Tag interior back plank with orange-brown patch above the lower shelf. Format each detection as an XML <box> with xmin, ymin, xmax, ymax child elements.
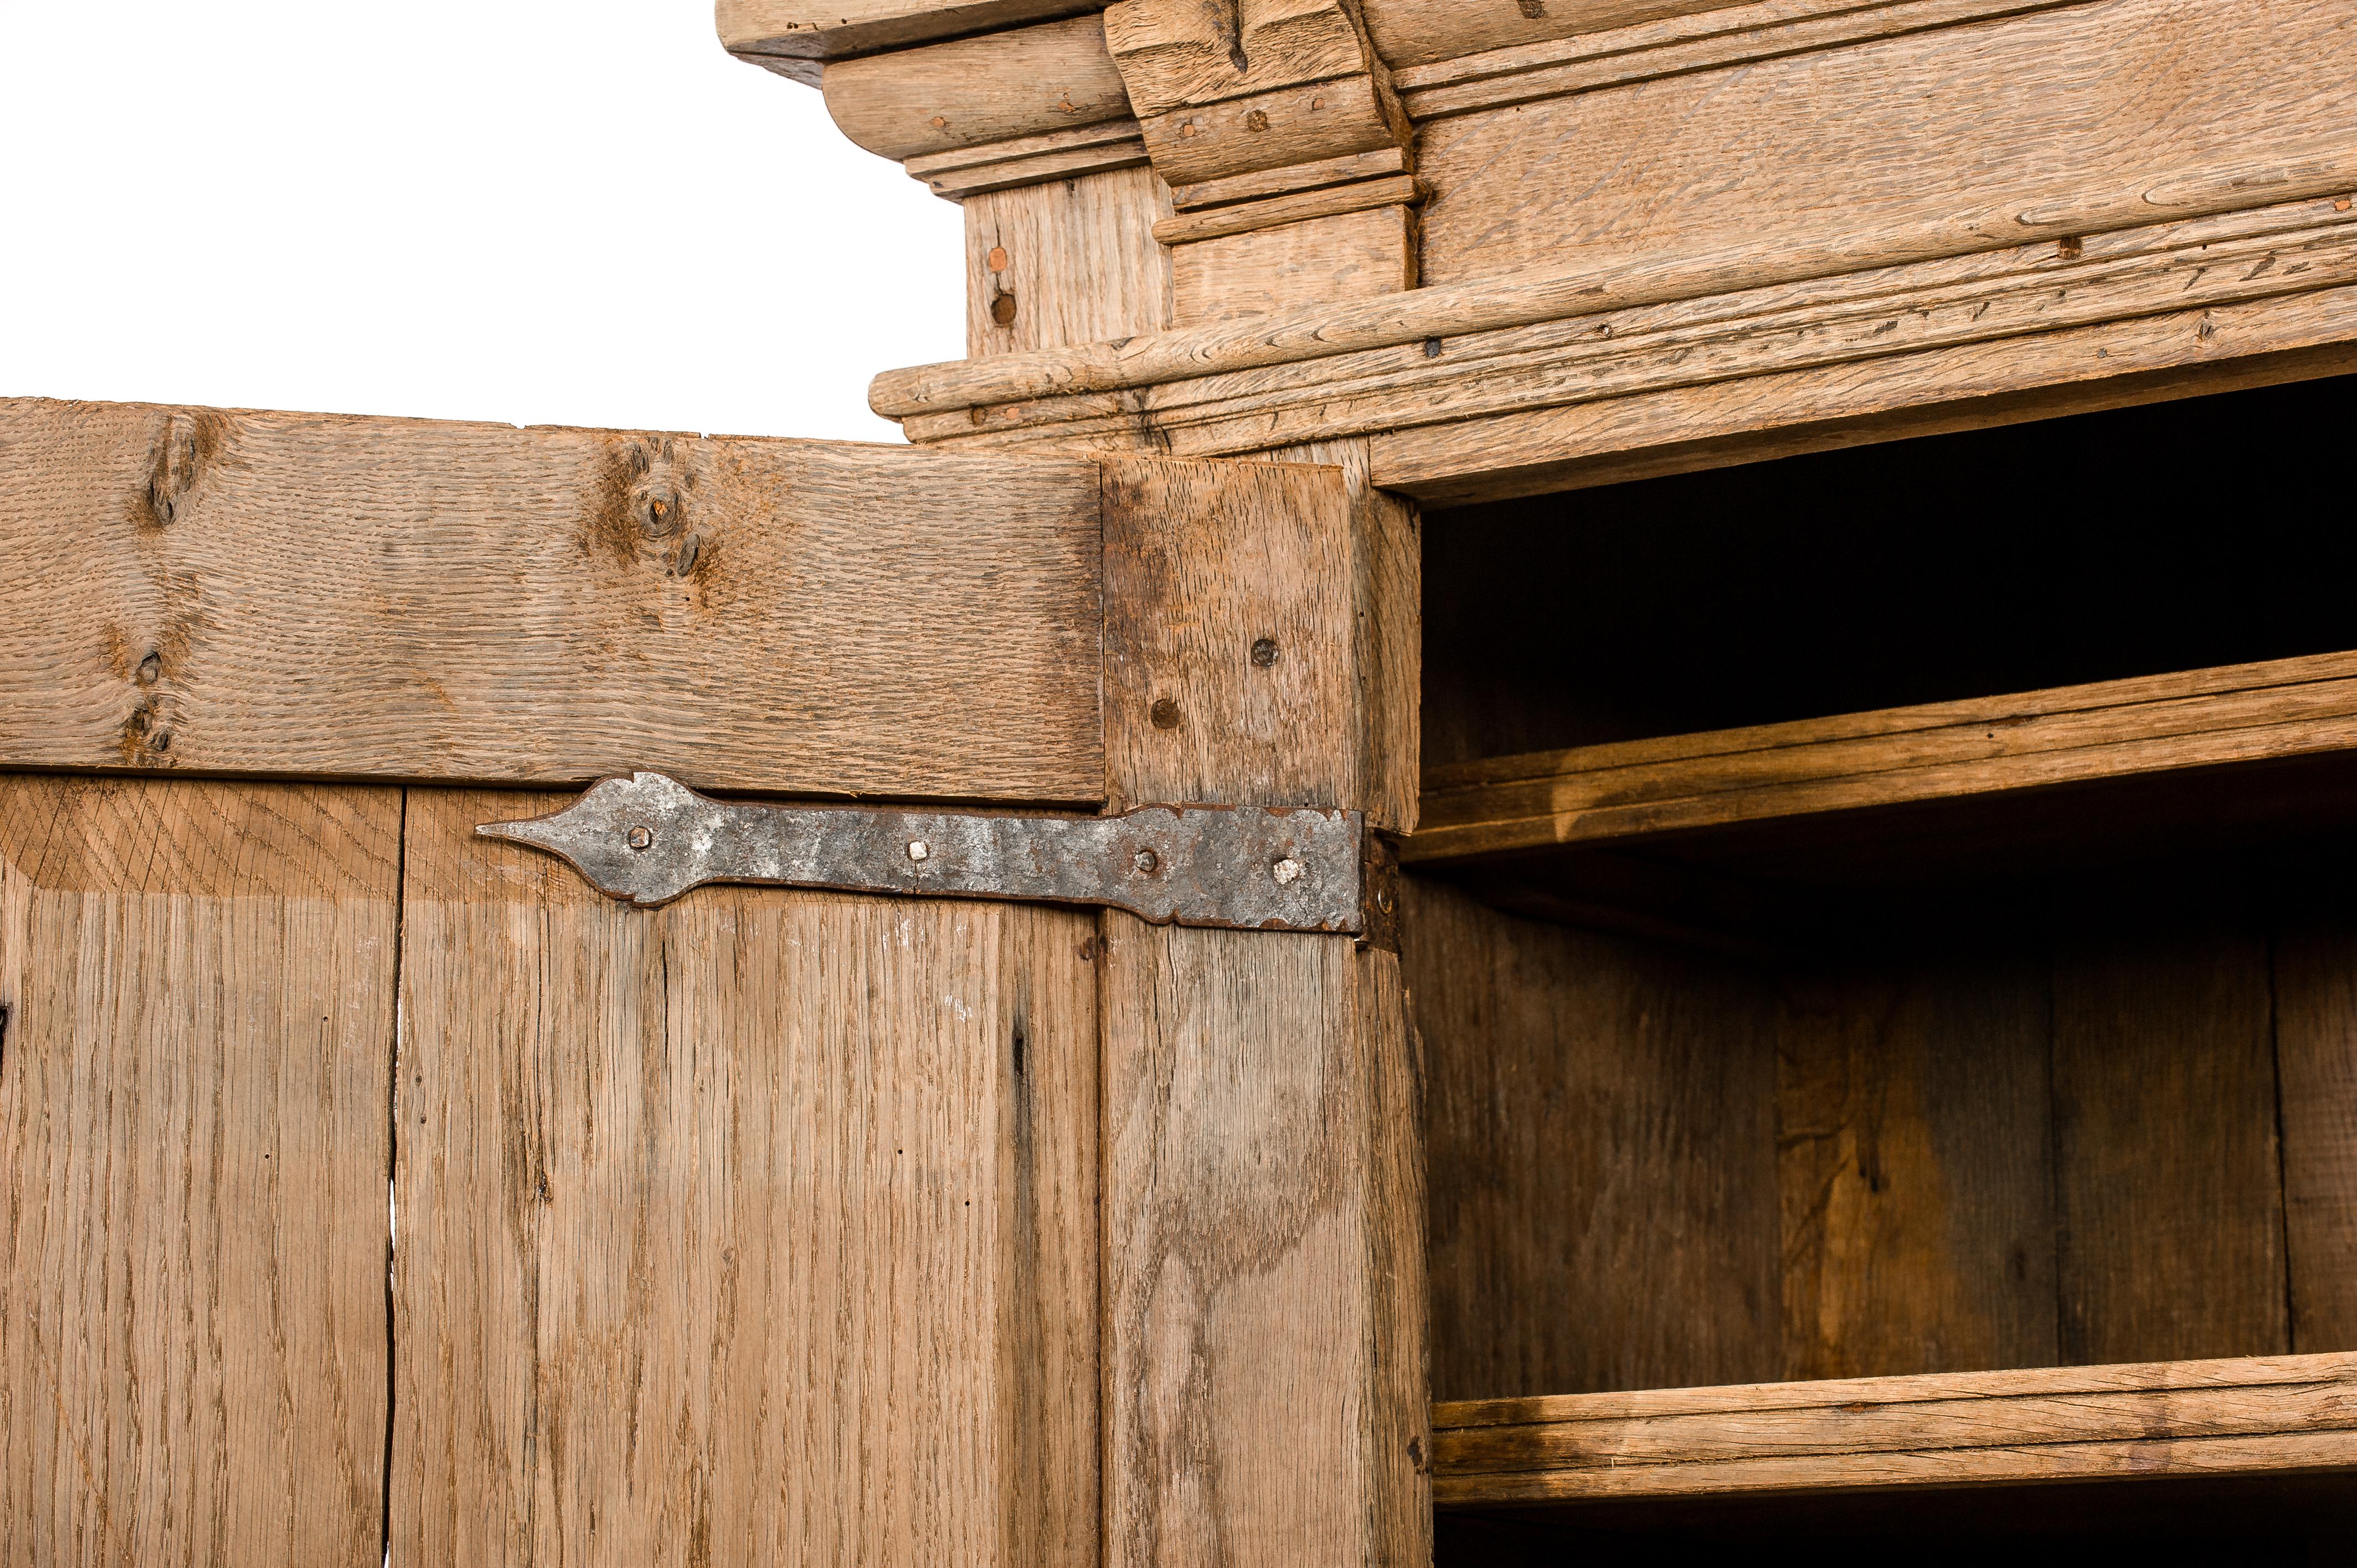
<box><xmin>1777</xmin><ymin>955</ymin><xmax>2057</xmax><ymax>1379</ymax></box>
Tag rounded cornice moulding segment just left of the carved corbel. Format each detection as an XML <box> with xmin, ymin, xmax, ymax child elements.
<box><xmin>825</xmin><ymin>17</ymin><xmax>1129</xmax><ymax>161</ymax></box>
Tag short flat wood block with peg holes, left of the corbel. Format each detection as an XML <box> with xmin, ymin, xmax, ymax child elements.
<box><xmin>966</xmin><ymin>167</ymin><xmax>1171</xmax><ymax>358</ymax></box>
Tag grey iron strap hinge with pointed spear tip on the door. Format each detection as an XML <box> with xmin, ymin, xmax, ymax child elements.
<box><xmin>476</xmin><ymin>773</ymin><xmax>1398</xmax><ymax>948</ymax></box>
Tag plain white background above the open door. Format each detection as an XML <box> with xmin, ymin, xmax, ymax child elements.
<box><xmin>0</xmin><ymin>0</ymin><xmax>964</xmax><ymax>441</ymax></box>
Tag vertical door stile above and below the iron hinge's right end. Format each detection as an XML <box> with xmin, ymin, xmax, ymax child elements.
<box><xmin>1098</xmin><ymin>450</ymin><xmax>1430</xmax><ymax>1568</ymax></box>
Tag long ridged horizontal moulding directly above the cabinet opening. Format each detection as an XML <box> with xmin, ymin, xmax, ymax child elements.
<box><xmin>869</xmin><ymin>194</ymin><xmax>2357</xmax><ymax>471</ymax></box>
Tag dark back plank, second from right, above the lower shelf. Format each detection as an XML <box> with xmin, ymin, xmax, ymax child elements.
<box><xmin>2053</xmin><ymin>910</ymin><xmax>2291</xmax><ymax>1365</ymax></box>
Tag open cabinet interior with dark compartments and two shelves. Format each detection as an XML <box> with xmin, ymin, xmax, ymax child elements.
<box><xmin>1405</xmin><ymin>380</ymin><xmax>2357</xmax><ymax>1561</ymax></box>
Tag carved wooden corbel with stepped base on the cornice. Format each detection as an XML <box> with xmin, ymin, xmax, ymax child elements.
<box><xmin>1105</xmin><ymin>0</ymin><xmax>1421</xmax><ymax>326</ymax></box>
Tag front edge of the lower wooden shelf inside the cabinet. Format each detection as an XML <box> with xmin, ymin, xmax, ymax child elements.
<box><xmin>1433</xmin><ymin>1353</ymin><xmax>2357</xmax><ymax>1509</ymax></box>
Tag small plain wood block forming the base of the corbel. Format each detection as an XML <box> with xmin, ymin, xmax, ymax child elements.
<box><xmin>1171</xmin><ymin>205</ymin><xmax>1417</xmax><ymax>326</ymax></box>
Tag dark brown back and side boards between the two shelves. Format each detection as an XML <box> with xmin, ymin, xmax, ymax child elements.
<box><xmin>1405</xmin><ymin>868</ymin><xmax>2357</xmax><ymax>1398</ymax></box>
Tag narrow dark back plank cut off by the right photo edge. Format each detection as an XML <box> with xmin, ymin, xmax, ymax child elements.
<box><xmin>2274</xmin><ymin>917</ymin><xmax>2357</xmax><ymax>1351</ymax></box>
